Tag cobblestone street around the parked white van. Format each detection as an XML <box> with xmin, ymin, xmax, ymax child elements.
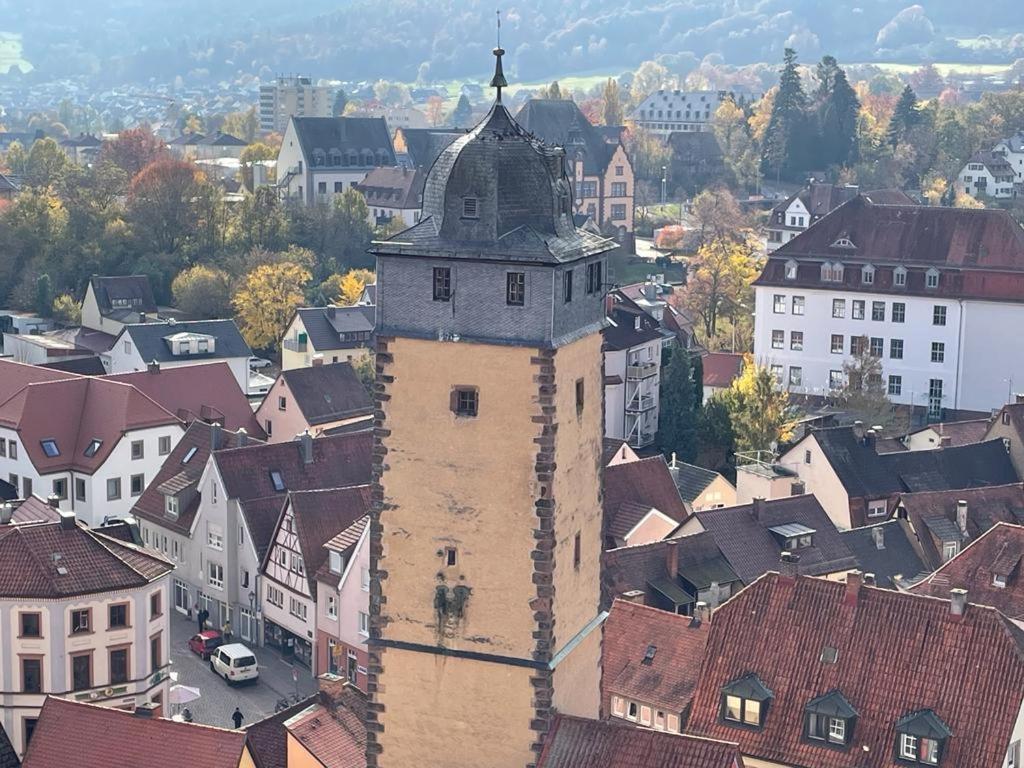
<box><xmin>169</xmin><ymin>612</ymin><xmax>316</xmax><ymax>728</ymax></box>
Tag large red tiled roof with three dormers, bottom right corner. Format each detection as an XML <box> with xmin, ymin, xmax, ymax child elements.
<box><xmin>688</xmin><ymin>573</ymin><xmax>1024</xmax><ymax>768</ymax></box>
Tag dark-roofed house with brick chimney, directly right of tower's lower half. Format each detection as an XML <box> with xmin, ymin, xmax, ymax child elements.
<box><xmin>601</xmin><ymin>532</ymin><xmax>743</xmax><ymax>615</ymax></box>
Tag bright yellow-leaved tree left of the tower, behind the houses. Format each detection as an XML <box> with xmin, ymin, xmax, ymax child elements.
<box><xmin>231</xmin><ymin>261</ymin><xmax>312</xmax><ymax>349</ymax></box>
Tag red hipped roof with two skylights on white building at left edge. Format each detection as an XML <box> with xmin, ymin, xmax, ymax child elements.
<box><xmin>0</xmin><ymin>374</ymin><xmax>180</xmax><ymax>474</ymax></box>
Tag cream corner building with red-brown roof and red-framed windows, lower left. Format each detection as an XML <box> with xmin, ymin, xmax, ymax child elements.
<box><xmin>0</xmin><ymin>512</ymin><xmax>174</xmax><ymax>766</ymax></box>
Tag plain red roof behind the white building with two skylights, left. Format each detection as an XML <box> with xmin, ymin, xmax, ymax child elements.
<box><xmin>103</xmin><ymin>360</ymin><xmax>264</xmax><ymax>438</ymax></box>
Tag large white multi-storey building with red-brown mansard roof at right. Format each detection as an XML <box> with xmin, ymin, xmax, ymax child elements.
<box><xmin>754</xmin><ymin>197</ymin><xmax>1024</xmax><ymax>419</ymax></box>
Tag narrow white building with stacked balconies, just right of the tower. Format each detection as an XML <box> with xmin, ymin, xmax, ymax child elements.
<box><xmin>601</xmin><ymin>293</ymin><xmax>665</xmax><ymax>447</ymax></box>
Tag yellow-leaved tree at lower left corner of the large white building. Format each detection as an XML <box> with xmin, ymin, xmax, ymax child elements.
<box><xmin>718</xmin><ymin>354</ymin><xmax>797</xmax><ymax>452</ymax></box>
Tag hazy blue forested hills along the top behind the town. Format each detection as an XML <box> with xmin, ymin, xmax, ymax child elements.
<box><xmin>0</xmin><ymin>0</ymin><xmax>1024</xmax><ymax>84</ymax></box>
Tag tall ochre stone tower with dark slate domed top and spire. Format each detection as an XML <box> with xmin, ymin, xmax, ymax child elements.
<box><xmin>368</xmin><ymin>48</ymin><xmax>614</xmax><ymax>768</ymax></box>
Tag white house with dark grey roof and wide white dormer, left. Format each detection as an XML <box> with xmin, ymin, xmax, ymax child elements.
<box><xmin>100</xmin><ymin>319</ymin><xmax>252</xmax><ymax>393</ymax></box>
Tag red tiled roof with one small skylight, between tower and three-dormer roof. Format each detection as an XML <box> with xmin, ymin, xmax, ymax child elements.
<box><xmin>601</xmin><ymin>600</ymin><xmax>708</xmax><ymax>714</ymax></box>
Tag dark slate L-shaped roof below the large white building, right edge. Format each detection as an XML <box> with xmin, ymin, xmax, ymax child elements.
<box><xmin>812</xmin><ymin>427</ymin><xmax>1019</xmax><ymax>498</ymax></box>
